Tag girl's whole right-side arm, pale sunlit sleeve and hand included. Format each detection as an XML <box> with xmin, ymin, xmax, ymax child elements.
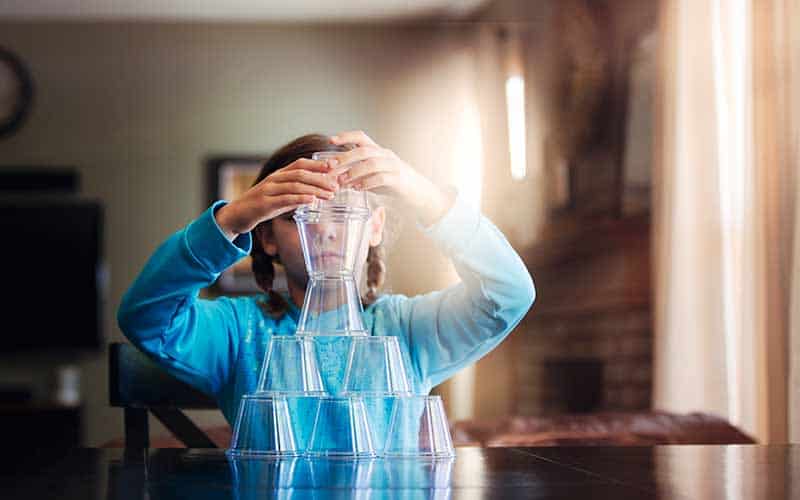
<box><xmin>331</xmin><ymin>131</ymin><xmax>535</xmax><ymax>388</ymax></box>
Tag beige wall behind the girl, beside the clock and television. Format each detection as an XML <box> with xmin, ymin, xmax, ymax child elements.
<box><xmin>0</xmin><ymin>23</ymin><xmax>512</xmax><ymax>445</ymax></box>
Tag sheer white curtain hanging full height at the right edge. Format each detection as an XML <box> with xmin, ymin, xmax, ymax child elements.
<box><xmin>654</xmin><ymin>0</ymin><xmax>798</xmax><ymax>442</ymax></box>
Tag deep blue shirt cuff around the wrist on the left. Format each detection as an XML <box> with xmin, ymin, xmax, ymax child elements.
<box><xmin>186</xmin><ymin>200</ymin><xmax>253</xmax><ymax>274</ymax></box>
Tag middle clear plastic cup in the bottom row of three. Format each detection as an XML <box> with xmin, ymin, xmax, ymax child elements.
<box><xmin>307</xmin><ymin>397</ymin><xmax>375</xmax><ymax>458</ymax></box>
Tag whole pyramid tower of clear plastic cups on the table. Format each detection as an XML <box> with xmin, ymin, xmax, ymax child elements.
<box><xmin>228</xmin><ymin>153</ymin><xmax>454</xmax><ymax>458</ymax></box>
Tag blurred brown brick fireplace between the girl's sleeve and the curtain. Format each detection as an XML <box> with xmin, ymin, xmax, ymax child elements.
<box><xmin>512</xmin><ymin>215</ymin><xmax>653</xmax><ymax>415</ymax></box>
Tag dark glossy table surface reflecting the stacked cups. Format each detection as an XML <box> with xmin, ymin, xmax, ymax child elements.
<box><xmin>0</xmin><ymin>445</ymin><xmax>800</xmax><ymax>500</ymax></box>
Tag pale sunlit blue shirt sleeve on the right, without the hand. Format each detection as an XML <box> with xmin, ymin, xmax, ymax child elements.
<box><xmin>395</xmin><ymin>191</ymin><xmax>535</xmax><ymax>389</ymax></box>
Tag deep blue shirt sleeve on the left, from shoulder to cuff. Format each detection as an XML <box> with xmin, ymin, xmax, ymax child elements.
<box><xmin>117</xmin><ymin>201</ymin><xmax>252</xmax><ymax>395</ymax></box>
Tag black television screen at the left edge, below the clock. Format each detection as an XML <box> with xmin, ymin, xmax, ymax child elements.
<box><xmin>0</xmin><ymin>196</ymin><xmax>103</xmax><ymax>352</ymax></box>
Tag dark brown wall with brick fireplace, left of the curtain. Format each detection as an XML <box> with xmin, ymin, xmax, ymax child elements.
<box><xmin>477</xmin><ymin>0</ymin><xmax>655</xmax><ymax>417</ymax></box>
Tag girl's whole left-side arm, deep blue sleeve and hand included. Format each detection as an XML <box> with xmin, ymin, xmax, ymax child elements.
<box><xmin>117</xmin><ymin>158</ymin><xmax>338</xmax><ymax>394</ymax></box>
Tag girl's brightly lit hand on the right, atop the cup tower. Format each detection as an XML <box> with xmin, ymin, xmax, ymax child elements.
<box><xmin>331</xmin><ymin>131</ymin><xmax>453</xmax><ymax>225</ymax></box>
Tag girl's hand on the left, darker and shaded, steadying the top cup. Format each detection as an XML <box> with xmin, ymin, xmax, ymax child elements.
<box><xmin>214</xmin><ymin>158</ymin><xmax>339</xmax><ymax>240</ymax></box>
